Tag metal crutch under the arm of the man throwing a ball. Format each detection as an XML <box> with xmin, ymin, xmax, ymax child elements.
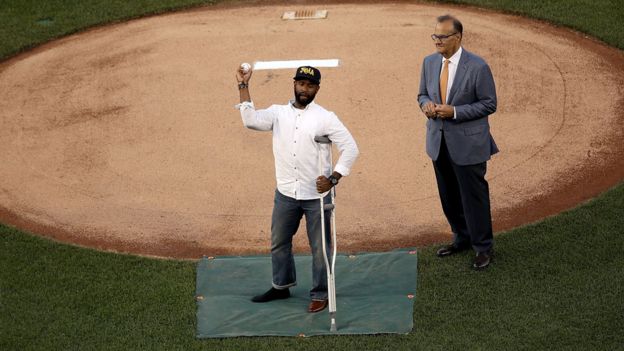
<box><xmin>314</xmin><ymin>136</ymin><xmax>338</xmax><ymax>332</ymax></box>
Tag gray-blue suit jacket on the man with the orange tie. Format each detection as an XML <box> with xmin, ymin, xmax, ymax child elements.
<box><xmin>418</xmin><ymin>49</ymin><xmax>498</xmax><ymax>166</ymax></box>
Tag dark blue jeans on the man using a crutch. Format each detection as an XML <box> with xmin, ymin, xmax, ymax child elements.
<box><xmin>271</xmin><ymin>190</ymin><xmax>331</xmax><ymax>300</ymax></box>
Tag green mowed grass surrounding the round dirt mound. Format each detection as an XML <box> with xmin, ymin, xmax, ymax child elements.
<box><xmin>0</xmin><ymin>0</ymin><xmax>624</xmax><ymax>350</ymax></box>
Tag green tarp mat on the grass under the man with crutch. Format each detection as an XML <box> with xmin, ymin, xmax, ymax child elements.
<box><xmin>196</xmin><ymin>250</ymin><xmax>417</xmax><ymax>338</ymax></box>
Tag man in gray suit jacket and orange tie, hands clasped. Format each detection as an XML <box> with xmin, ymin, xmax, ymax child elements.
<box><xmin>418</xmin><ymin>15</ymin><xmax>498</xmax><ymax>269</ymax></box>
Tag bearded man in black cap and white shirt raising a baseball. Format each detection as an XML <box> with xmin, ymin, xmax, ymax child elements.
<box><xmin>236</xmin><ymin>66</ymin><xmax>359</xmax><ymax>312</ymax></box>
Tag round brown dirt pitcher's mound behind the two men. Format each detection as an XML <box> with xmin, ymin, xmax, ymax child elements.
<box><xmin>0</xmin><ymin>3</ymin><xmax>624</xmax><ymax>258</ymax></box>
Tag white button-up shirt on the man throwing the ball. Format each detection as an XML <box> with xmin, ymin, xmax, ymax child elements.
<box><xmin>236</xmin><ymin>101</ymin><xmax>359</xmax><ymax>200</ymax></box>
